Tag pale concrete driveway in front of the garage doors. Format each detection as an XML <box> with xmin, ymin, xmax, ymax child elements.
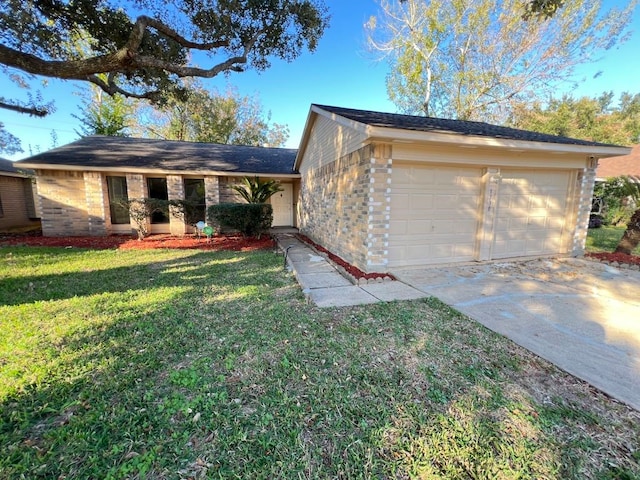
<box><xmin>393</xmin><ymin>258</ymin><xmax>640</xmax><ymax>410</ymax></box>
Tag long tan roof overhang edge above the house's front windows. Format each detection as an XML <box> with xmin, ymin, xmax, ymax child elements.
<box><xmin>13</xmin><ymin>161</ymin><xmax>300</xmax><ymax>179</ymax></box>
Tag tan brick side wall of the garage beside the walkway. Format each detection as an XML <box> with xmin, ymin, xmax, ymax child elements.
<box><xmin>298</xmin><ymin>145</ymin><xmax>392</xmax><ymax>272</ymax></box>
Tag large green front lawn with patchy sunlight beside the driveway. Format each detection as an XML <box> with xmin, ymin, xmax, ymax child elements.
<box><xmin>0</xmin><ymin>247</ymin><xmax>640</xmax><ymax>479</ymax></box>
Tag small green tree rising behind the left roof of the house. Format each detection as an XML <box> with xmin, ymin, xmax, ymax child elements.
<box><xmin>74</xmin><ymin>83</ymin><xmax>133</xmax><ymax>137</ymax></box>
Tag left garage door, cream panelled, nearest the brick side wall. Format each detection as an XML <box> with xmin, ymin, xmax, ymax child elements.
<box><xmin>389</xmin><ymin>166</ymin><xmax>482</xmax><ymax>267</ymax></box>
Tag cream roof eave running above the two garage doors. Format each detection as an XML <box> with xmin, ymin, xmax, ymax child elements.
<box><xmin>368</xmin><ymin>126</ymin><xmax>631</xmax><ymax>158</ymax></box>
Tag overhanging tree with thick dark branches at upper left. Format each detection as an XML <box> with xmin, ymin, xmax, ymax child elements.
<box><xmin>0</xmin><ymin>0</ymin><xmax>328</xmax><ymax>115</ymax></box>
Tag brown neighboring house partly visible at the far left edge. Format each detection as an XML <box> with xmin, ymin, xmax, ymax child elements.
<box><xmin>0</xmin><ymin>158</ymin><xmax>37</xmax><ymax>231</ymax></box>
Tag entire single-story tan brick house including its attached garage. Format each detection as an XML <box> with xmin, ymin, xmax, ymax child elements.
<box><xmin>15</xmin><ymin>105</ymin><xmax>630</xmax><ymax>272</ymax></box>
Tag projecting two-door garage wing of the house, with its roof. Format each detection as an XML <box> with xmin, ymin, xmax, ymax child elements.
<box><xmin>295</xmin><ymin>105</ymin><xmax>629</xmax><ymax>272</ymax></box>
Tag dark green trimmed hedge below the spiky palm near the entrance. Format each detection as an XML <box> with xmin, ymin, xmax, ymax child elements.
<box><xmin>207</xmin><ymin>203</ymin><xmax>273</xmax><ymax>238</ymax></box>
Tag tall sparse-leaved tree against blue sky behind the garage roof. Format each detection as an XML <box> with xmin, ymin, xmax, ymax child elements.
<box><xmin>365</xmin><ymin>0</ymin><xmax>637</xmax><ymax>123</ymax></box>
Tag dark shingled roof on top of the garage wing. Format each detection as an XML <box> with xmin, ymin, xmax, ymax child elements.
<box><xmin>315</xmin><ymin>105</ymin><xmax>616</xmax><ymax>147</ymax></box>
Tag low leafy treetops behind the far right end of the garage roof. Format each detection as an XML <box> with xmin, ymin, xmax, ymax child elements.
<box><xmin>508</xmin><ymin>92</ymin><xmax>640</xmax><ymax>145</ymax></box>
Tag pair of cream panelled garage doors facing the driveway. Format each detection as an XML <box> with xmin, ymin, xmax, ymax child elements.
<box><xmin>389</xmin><ymin>164</ymin><xmax>573</xmax><ymax>268</ymax></box>
